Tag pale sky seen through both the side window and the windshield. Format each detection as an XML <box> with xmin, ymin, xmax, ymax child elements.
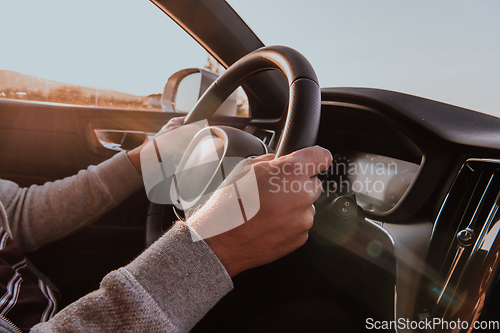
<box><xmin>0</xmin><ymin>0</ymin><xmax>500</xmax><ymax>116</ymax></box>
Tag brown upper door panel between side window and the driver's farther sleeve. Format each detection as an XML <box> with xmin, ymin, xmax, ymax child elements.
<box><xmin>0</xmin><ymin>99</ymin><xmax>175</xmax><ymax>185</ymax></box>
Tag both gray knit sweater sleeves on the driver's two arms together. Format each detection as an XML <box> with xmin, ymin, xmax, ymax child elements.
<box><xmin>0</xmin><ymin>153</ymin><xmax>233</xmax><ymax>332</ymax></box>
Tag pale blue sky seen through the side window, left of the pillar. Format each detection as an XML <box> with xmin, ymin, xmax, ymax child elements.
<box><xmin>0</xmin><ymin>0</ymin><xmax>207</xmax><ymax>95</ymax></box>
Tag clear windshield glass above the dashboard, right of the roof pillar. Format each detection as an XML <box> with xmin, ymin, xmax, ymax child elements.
<box><xmin>228</xmin><ymin>0</ymin><xmax>500</xmax><ymax>116</ymax></box>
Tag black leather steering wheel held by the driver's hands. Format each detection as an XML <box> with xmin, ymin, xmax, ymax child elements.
<box><xmin>146</xmin><ymin>46</ymin><xmax>321</xmax><ymax>245</ymax></box>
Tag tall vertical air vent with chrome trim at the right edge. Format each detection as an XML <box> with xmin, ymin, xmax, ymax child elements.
<box><xmin>421</xmin><ymin>159</ymin><xmax>500</xmax><ymax>331</ymax></box>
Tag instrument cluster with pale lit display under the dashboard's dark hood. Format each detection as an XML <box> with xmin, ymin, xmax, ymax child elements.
<box><xmin>318</xmin><ymin>101</ymin><xmax>424</xmax><ymax>216</ymax></box>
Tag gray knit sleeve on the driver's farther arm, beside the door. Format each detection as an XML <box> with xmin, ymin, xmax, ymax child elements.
<box><xmin>0</xmin><ymin>152</ymin><xmax>142</xmax><ymax>251</ymax></box>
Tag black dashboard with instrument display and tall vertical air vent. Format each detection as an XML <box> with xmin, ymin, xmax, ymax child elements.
<box><xmin>311</xmin><ymin>88</ymin><xmax>500</xmax><ymax>328</ymax></box>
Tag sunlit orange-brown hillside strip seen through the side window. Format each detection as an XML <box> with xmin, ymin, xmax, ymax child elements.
<box><xmin>0</xmin><ymin>70</ymin><xmax>158</xmax><ymax>110</ymax></box>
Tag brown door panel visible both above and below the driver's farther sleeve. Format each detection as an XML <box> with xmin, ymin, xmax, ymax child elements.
<box><xmin>0</xmin><ymin>99</ymin><xmax>175</xmax><ymax>305</ymax></box>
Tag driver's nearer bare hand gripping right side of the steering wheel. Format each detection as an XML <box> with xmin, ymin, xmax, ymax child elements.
<box><xmin>187</xmin><ymin>146</ymin><xmax>332</xmax><ymax>277</ymax></box>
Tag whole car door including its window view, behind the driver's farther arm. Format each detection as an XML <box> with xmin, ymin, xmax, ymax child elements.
<box><xmin>0</xmin><ymin>1</ymin><xmax>221</xmax><ymax>306</ymax></box>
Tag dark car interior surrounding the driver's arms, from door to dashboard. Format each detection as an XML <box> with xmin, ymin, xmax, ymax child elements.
<box><xmin>0</xmin><ymin>0</ymin><xmax>500</xmax><ymax>332</ymax></box>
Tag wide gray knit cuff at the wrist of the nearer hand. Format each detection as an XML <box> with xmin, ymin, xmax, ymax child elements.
<box><xmin>123</xmin><ymin>222</ymin><xmax>233</xmax><ymax>332</ymax></box>
